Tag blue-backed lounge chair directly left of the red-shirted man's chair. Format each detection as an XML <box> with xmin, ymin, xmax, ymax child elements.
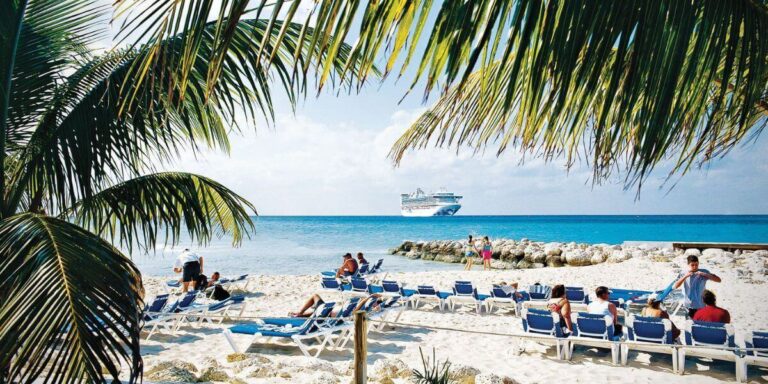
<box><xmin>621</xmin><ymin>316</ymin><xmax>678</xmax><ymax>373</ymax></box>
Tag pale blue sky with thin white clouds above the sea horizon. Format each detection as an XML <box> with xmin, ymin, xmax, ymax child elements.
<box><xmin>109</xmin><ymin>1</ymin><xmax>768</xmax><ymax>215</ymax></box>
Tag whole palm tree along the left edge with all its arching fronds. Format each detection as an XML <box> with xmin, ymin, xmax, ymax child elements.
<box><xmin>0</xmin><ymin>0</ymin><xmax>362</xmax><ymax>382</ymax></box>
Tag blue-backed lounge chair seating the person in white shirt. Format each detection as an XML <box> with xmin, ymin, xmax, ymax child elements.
<box><xmin>568</xmin><ymin>312</ymin><xmax>622</xmax><ymax>364</ymax></box>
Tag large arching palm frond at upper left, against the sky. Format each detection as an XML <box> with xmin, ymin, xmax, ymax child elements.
<box><xmin>3</xmin><ymin>20</ymin><xmax>356</xmax><ymax>216</ymax></box>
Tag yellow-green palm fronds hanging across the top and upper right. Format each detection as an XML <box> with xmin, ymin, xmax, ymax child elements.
<box><xmin>123</xmin><ymin>0</ymin><xmax>768</xmax><ymax>186</ymax></box>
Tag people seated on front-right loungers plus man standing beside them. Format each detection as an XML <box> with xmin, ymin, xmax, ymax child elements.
<box><xmin>516</xmin><ymin>256</ymin><xmax>731</xmax><ymax>339</ymax></box>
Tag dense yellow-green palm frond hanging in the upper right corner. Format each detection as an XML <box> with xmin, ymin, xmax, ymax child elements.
<box><xmin>390</xmin><ymin>1</ymin><xmax>768</xmax><ymax>187</ymax></box>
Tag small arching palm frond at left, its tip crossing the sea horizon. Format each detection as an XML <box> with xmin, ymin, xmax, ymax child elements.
<box><xmin>68</xmin><ymin>172</ymin><xmax>256</xmax><ymax>249</ymax></box>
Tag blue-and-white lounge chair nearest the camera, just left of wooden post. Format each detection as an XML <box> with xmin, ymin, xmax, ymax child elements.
<box><xmin>224</xmin><ymin>303</ymin><xmax>335</xmax><ymax>357</ymax></box>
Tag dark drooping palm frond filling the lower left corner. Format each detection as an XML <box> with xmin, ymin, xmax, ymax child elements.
<box><xmin>0</xmin><ymin>213</ymin><xmax>143</xmax><ymax>383</ymax></box>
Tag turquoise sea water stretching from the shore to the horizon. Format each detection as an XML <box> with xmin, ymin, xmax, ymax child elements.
<box><xmin>133</xmin><ymin>215</ymin><xmax>768</xmax><ymax>276</ymax></box>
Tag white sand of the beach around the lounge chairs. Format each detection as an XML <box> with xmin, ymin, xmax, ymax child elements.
<box><xmin>142</xmin><ymin>252</ymin><xmax>768</xmax><ymax>383</ymax></box>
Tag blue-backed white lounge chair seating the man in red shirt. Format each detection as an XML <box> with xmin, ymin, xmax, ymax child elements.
<box><xmin>678</xmin><ymin>320</ymin><xmax>746</xmax><ymax>381</ymax></box>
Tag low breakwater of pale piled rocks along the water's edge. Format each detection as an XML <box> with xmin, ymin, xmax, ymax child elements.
<box><xmin>390</xmin><ymin>239</ymin><xmax>682</xmax><ymax>269</ymax></box>
